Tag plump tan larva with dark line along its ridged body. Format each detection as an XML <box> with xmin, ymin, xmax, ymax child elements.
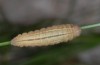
<box><xmin>11</xmin><ymin>24</ymin><xmax>81</xmax><ymax>47</ymax></box>
